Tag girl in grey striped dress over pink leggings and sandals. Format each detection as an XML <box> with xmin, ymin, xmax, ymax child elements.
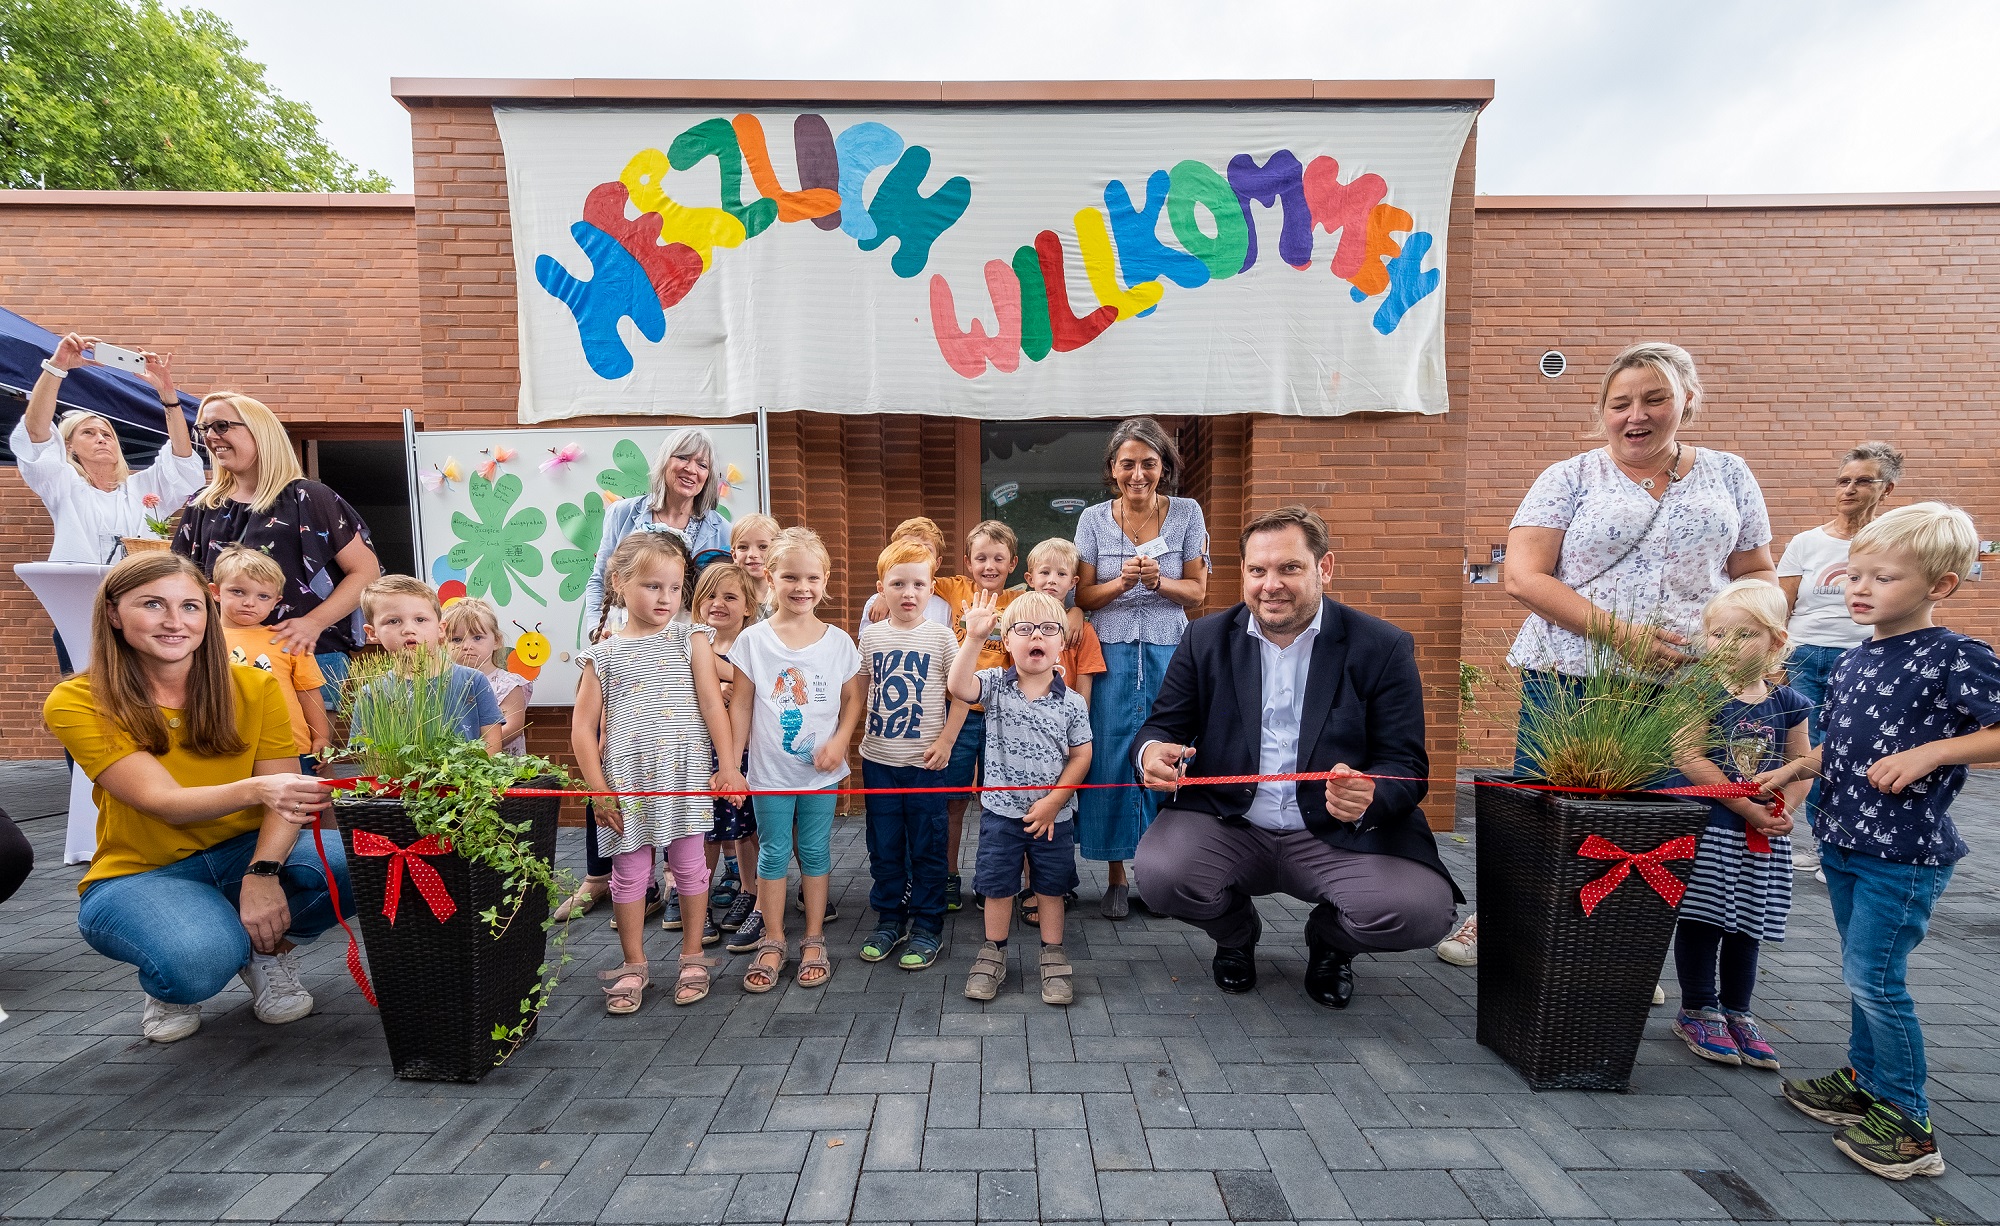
<box><xmin>570</xmin><ymin>532</ymin><xmax>742</xmax><ymax>1014</ymax></box>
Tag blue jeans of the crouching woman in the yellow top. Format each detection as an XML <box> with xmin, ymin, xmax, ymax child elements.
<box><xmin>76</xmin><ymin>830</ymin><xmax>354</xmax><ymax>1004</ymax></box>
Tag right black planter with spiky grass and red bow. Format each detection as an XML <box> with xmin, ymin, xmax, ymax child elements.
<box><xmin>1474</xmin><ymin>630</ymin><xmax>1726</xmax><ymax>1090</ymax></box>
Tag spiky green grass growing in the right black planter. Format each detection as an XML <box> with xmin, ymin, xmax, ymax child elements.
<box><xmin>1496</xmin><ymin>628</ymin><xmax>1728</xmax><ymax>792</ymax></box>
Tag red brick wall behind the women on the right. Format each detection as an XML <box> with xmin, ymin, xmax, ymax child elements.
<box><xmin>1454</xmin><ymin>202</ymin><xmax>2000</xmax><ymax>760</ymax></box>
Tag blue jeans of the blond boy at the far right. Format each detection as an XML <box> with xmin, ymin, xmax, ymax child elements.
<box><xmin>1820</xmin><ymin>842</ymin><xmax>1952</xmax><ymax>1120</ymax></box>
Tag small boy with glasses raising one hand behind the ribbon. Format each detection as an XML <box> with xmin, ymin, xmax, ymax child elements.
<box><xmin>952</xmin><ymin>592</ymin><xmax>1090</xmax><ymax>1004</ymax></box>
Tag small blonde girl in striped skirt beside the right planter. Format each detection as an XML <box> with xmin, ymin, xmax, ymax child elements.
<box><xmin>1674</xmin><ymin>578</ymin><xmax>1810</xmax><ymax>1068</ymax></box>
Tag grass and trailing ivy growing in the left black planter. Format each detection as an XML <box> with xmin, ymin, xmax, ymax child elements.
<box><xmin>340</xmin><ymin>648</ymin><xmax>576</xmax><ymax>1064</ymax></box>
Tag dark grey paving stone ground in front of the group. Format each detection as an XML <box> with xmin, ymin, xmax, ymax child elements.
<box><xmin>0</xmin><ymin>766</ymin><xmax>2000</xmax><ymax>1222</ymax></box>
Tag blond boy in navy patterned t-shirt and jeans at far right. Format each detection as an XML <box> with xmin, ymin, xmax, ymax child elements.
<box><xmin>1758</xmin><ymin>502</ymin><xmax>2000</xmax><ymax>1180</ymax></box>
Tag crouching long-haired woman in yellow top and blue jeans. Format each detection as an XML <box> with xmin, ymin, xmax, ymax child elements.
<box><xmin>42</xmin><ymin>554</ymin><xmax>352</xmax><ymax>1042</ymax></box>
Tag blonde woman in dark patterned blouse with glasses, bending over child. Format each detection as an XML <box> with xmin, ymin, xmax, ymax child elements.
<box><xmin>174</xmin><ymin>392</ymin><xmax>382</xmax><ymax>682</ymax></box>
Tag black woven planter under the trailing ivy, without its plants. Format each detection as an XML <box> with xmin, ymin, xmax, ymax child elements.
<box><xmin>334</xmin><ymin>780</ymin><xmax>562</xmax><ymax>1082</ymax></box>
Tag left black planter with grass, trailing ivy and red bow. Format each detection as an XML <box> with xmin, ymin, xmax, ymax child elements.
<box><xmin>334</xmin><ymin>648</ymin><xmax>574</xmax><ymax>1082</ymax></box>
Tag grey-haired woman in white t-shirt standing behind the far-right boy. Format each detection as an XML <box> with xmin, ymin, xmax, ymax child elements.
<box><xmin>1778</xmin><ymin>442</ymin><xmax>1902</xmax><ymax>870</ymax></box>
